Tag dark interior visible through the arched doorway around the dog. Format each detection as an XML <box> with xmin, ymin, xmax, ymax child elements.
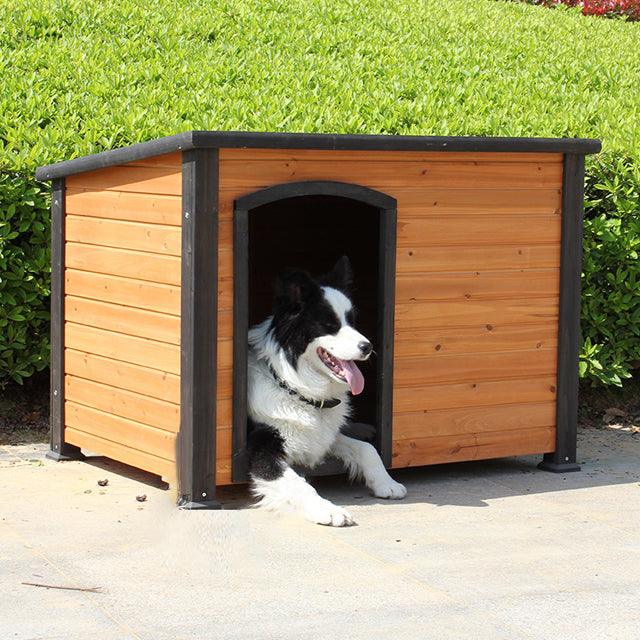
<box><xmin>248</xmin><ymin>195</ymin><xmax>381</xmax><ymax>442</ymax></box>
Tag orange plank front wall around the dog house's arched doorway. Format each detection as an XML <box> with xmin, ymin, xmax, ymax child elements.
<box><xmin>217</xmin><ymin>149</ymin><xmax>562</xmax><ymax>468</ymax></box>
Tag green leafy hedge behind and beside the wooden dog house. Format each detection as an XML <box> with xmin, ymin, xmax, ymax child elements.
<box><xmin>0</xmin><ymin>0</ymin><xmax>640</xmax><ymax>383</ymax></box>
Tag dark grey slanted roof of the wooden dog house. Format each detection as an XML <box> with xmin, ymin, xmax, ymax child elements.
<box><xmin>36</xmin><ymin>131</ymin><xmax>601</xmax><ymax>180</ymax></box>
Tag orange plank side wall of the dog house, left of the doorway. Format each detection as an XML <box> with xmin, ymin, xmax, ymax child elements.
<box><xmin>63</xmin><ymin>153</ymin><xmax>182</xmax><ymax>479</ymax></box>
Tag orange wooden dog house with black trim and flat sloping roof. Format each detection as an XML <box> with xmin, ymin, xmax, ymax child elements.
<box><xmin>36</xmin><ymin>131</ymin><xmax>600</xmax><ymax>508</ymax></box>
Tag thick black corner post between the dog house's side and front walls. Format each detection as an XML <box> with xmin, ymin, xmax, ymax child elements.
<box><xmin>176</xmin><ymin>149</ymin><xmax>220</xmax><ymax>509</ymax></box>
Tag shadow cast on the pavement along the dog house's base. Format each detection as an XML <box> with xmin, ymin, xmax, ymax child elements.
<box><xmin>51</xmin><ymin>428</ymin><xmax>640</xmax><ymax>509</ymax></box>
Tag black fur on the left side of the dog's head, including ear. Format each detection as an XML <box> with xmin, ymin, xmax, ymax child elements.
<box><xmin>272</xmin><ymin>270</ymin><xmax>341</xmax><ymax>368</ymax></box>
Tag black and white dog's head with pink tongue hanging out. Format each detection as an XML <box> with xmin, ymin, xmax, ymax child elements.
<box><xmin>272</xmin><ymin>256</ymin><xmax>372</xmax><ymax>395</ymax></box>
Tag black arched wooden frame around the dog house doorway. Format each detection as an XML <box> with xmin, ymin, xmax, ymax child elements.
<box><xmin>232</xmin><ymin>180</ymin><xmax>397</xmax><ymax>482</ymax></box>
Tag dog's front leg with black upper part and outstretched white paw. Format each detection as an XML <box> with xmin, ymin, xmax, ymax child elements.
<box><xmin>247</xmin><ymin>425</ymin><xmax>354</xmax><ymax>527</ymax></box>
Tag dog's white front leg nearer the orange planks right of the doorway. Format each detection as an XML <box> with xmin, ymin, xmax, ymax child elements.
<box><xmin>331</xmin><ymin>433</ymin><xmax>407</xmax><ymax>500</ymax></box>
